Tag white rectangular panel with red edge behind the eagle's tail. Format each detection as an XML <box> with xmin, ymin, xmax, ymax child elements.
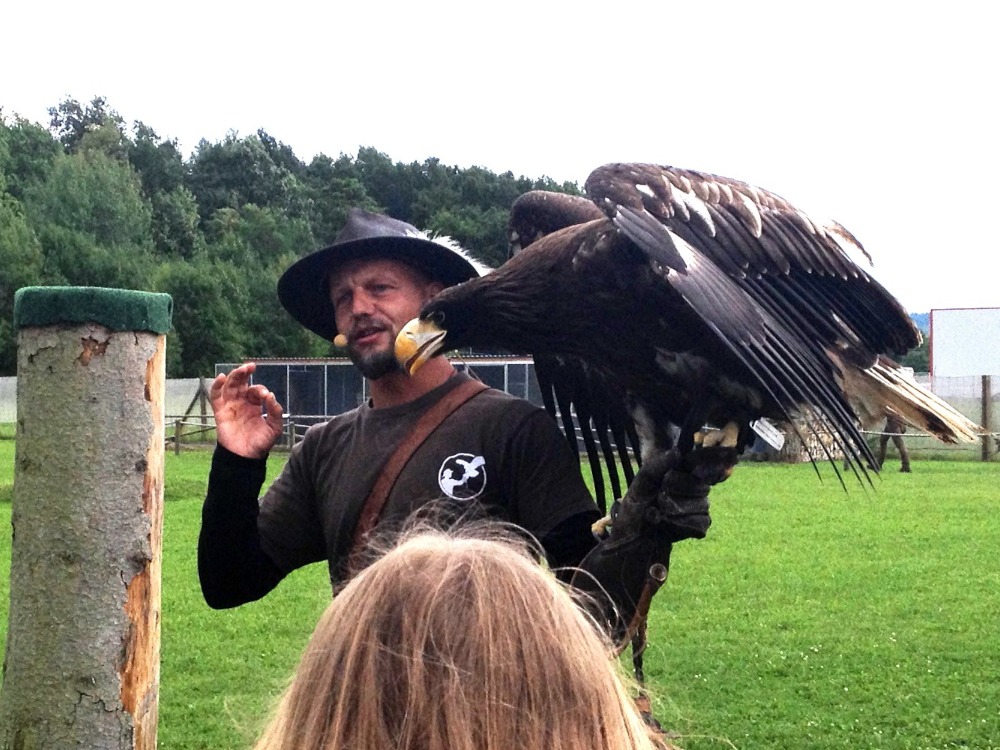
<box><xmin>930</xmin><ymin>307</ymin><xmax>1000</xmax><ymax>377</ymax></box>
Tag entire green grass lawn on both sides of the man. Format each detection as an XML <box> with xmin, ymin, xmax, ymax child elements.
<box><xmin>0</xmin><ymin>440</ymin><xmax>1000</xmax><ymax>750</ymax></box>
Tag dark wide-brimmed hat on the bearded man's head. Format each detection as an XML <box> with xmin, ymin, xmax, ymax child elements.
<box><xmin>278</xmin><ymin>208</ymin><xmax>480</xmax><ymax>341</ymax></box>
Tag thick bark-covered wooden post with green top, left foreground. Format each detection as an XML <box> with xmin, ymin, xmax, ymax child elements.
<box><xmin>0</xmin><ymin>287</ymin><xmax>171</xmax><ymax>750</ymax></box>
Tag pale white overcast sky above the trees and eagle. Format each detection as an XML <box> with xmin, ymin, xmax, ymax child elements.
<box><xmin>0</xmin><ymin>0</ymin><xmax>1000</xmax><ymax>312</ymax></box>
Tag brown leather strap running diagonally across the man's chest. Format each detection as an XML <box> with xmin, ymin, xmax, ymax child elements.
<box><xmin>348</xmin><ymin>380</ymin><xmax>488</xmax><ymax>575</ymax></box>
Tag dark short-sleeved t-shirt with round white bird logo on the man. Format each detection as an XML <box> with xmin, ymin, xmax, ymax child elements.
<box><xmin>257</xmin><ymin>375</ymin><xmax>596</xmax><ymax>578</ymax></box>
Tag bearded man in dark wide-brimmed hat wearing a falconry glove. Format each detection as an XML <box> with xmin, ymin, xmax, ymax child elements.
<box><xmin>198</xmin><ymin>209</ymin><xmax>728</xmax><ymax>640</ymax></box>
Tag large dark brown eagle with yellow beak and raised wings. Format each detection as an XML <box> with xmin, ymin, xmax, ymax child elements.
<box><xmin>396</xmin><ymin>164</ymin><xmax>979</xmax><ymax>504</ymax></box>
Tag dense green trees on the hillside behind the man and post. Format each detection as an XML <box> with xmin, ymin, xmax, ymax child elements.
<box><xmin>0</xmin><ymin>97</ymin><xmax>579</xmax><ymax>377</ymax></box>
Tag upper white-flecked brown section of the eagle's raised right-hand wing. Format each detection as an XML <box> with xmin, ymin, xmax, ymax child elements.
<box><xmin>586</xmin><ymin>164</ymin><xmax>920</xmax><ymax>366</ymax></box>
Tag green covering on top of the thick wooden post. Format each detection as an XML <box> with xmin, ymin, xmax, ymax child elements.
<box><xmin>14</xmin><ymin>286</ymin><xmax>173</xmax><ymax>333</ymax></box>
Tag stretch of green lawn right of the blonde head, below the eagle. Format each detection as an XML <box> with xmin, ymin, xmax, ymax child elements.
<box><xmin>648</xmin><ymin>462</ymin><xmax>1000</xmax><ymax>750</ymax></box>
